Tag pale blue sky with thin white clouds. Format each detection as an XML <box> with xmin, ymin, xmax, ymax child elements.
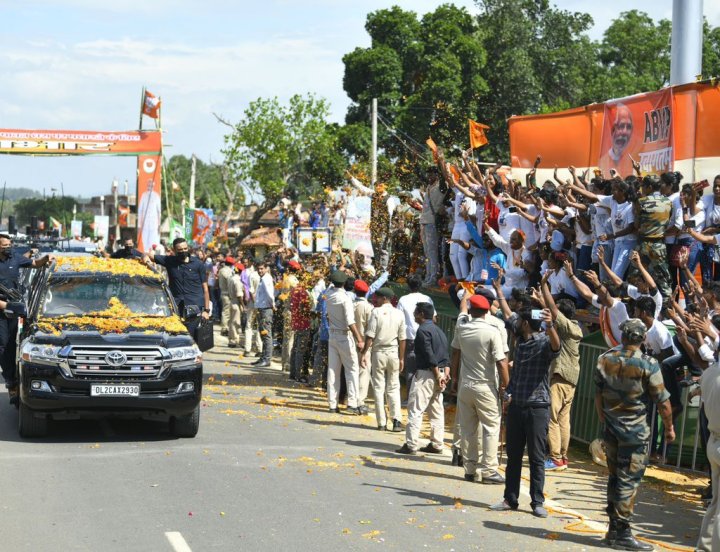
<box><xmin>0</xmin><ymin>0</ymin><xmax>720</xmax><ymax>197</ymax></box>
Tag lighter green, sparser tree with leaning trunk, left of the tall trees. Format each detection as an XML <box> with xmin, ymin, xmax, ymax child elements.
<box><xmin>216</xmin><ymin>94</ymin><xmax>346</xmax><ymax>234</ymax></box>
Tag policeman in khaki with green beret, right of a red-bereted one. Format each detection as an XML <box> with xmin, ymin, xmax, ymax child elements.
<box><xmin>361</xmin><ymin>287</ymin><xmax>407</xmax><ymax>432</ymax></box>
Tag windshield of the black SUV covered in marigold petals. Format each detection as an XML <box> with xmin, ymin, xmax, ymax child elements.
<box><xmin>41</xmin><ymin>275</ymin><xmax>172</xmax><ymax>318</ymax></box>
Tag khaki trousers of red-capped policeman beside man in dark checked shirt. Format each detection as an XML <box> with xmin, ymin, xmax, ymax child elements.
<box><xmin>457</xmin><ymin>381</ymin><xmax>500</xmax><ymax>475</ymax></box>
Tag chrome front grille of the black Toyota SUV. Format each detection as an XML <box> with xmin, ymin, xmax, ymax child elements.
<box><xmin>68</xmin><ymin>346</ymin><xmax>163</xmax><ymax>379</ymax></box>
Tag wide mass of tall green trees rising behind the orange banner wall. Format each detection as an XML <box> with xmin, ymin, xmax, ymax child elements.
<box><xmin>341</xmin><ymin>0</ymin><xmax>720</xmax><ymax>163</ymax></box>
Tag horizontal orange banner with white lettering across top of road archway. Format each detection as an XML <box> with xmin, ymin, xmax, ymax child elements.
<box><xmin>0</xmin><ymin>129</ymin><xmax>162</xmax><ymax>155</ymax></box>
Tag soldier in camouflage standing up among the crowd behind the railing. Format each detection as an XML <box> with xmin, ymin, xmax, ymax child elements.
<box><xmin>634</xmin><ymin>175</ymin><xmax>672</xmax><ymax>299</ymax></box>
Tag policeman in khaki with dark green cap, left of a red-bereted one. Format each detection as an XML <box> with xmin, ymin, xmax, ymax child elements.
<box><xmin>325</xmin><ymin>270</ymin><xmax>364</xmax><ymax>414</ymax></box>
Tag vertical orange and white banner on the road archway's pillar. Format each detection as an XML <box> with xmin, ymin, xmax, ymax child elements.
<box><xmin>137</xmin><ymin>155</ymin><xmax>162</xmax><ymax>253</ymax></box>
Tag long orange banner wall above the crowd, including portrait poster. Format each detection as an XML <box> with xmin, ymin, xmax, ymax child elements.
<box><xmin>508</xmin><ymin>82</ymin><xmax>720</xmax><ymax>175</ymax></box>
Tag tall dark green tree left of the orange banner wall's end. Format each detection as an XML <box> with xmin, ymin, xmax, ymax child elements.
<box><xmin>342</xmin><ymin>4</ymin><xmax>487</xmax><ymax>189</ymax></box>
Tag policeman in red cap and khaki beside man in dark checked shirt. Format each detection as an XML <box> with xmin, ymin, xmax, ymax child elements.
<box><xmin>450</xmin><ymin>293</ymin><xmax>510</xmax><ymax>485</ymax></box>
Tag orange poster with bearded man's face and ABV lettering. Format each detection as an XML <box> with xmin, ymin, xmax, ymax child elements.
<box><xmin>598</xmin><ymin>88</ymin><xmax>674</xmax><ymax>177</ymax></box>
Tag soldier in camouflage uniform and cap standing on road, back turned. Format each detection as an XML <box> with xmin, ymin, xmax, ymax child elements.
<box><xmin>594</xmin><ymin>318</ymin><xmax>675</xmax><ymax>550</ymax></box>
